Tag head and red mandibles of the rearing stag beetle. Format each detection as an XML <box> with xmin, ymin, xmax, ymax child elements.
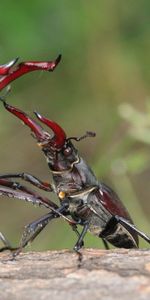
<box><xmin>0</xmin><ymin>98</ymin><xmax>78</xmax><ymax>172</ymax></box>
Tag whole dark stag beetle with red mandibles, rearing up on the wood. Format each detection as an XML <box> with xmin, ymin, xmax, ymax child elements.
<box><xmin>0</xmin><ymin>55</ymin><xmax>150</xmax><ymax>258</ymax></box>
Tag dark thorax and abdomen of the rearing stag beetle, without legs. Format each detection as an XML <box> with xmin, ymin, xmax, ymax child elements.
<box><xmin>50</xmin><ymin>152</ymin><xmax>138</xmax><ymax>248</ymax></box>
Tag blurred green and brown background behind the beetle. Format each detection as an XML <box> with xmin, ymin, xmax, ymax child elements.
<box><xmin>0</xmin><ymin>0</ymin><xmax>150</xmax><ymax>250</ymax></box>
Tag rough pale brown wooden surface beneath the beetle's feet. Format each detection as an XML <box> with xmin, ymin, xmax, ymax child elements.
<box><xmin>0</xmin><ymin>249</ymin><xmax>150</xmax><ymax>300</ymax></box>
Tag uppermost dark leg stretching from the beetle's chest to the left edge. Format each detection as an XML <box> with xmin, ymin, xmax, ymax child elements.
<box><xmin>0</xmin><ymin>173</ymin><xmax>53</xmax><ymax>192</ymax></box>
